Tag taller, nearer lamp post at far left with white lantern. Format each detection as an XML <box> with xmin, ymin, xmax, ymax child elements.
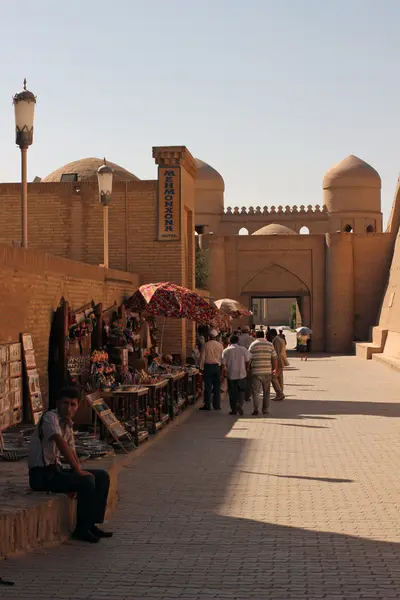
<box><xmin>13</xmin><ymin>79</ymin><xmax>36</xmax><ymax>248</ymax></box>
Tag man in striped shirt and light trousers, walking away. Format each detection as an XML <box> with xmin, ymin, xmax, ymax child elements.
<box><xmin>249</xmin><ymin>331</ymin><xmax>283</xmax><ymax>416</ymax></box>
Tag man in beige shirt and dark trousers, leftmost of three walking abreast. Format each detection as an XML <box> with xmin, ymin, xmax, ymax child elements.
<box><xmin>200</xmin><ymin>329</ymin><xmax>224</xmax><ymax>410</ymax></box>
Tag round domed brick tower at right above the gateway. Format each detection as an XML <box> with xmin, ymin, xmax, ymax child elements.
<box><xmin>322</xmin><ymin>154</ymin><xmax>382</xmax><ymax>233</ymax></box>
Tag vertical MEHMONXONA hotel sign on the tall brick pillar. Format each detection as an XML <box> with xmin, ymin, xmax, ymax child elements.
<box><xmin>157</xmin><ymin>167</ymin><xmax>181</xmax><ymax>242</ymax></box>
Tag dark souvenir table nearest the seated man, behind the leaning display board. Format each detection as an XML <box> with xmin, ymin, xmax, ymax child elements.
<box><xmin>100</xmin><ymin>385</ymin><xmax>149</xmax><ymax>446</ymax></box>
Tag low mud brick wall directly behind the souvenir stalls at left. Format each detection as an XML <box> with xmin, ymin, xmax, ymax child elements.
<box><xmin>0</xmin><ymin>244</ymin><xmax>139</xmax><ymax>398</ymax></box>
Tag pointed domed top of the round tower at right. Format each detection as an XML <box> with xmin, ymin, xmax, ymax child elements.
<box><xmin>322</xmin><ymin>154</ymin><xmax>381</xmax><ymax>189</ymax></box>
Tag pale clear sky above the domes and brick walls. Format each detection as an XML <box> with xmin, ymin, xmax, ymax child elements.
<box><xmin>0</xmin><ymin>0</ymin><xmax>400</xmax><ymax>220</ymax></box>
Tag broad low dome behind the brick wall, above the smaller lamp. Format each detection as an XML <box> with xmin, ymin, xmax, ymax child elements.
<box><xmin>42</xmin><ymin>158</ymin><xmax>139</xmax><ymax>183</ymax></box>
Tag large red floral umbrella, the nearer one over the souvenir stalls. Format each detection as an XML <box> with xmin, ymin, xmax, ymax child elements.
<box><xmin>127</xmin><ymin>282</ymin><xmax>220</xmax><ymax>325</ymax></box>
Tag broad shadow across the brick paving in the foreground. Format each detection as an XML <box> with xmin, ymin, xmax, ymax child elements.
<box><xmin>2</xmin><ymin>410</ymin><xmax>400</xmax><ymax>600</ymax></box>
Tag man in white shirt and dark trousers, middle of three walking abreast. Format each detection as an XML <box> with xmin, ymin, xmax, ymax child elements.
<box><xmin>222</xmin><ymin>335</ymin><xmax>250</xmax><ymax>415</ymax></box>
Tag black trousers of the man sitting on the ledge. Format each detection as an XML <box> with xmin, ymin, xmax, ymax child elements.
<box><xmin>29</xmin><ymin>467</ymin><xmax>110</xmax><ymax>529</ymax></box>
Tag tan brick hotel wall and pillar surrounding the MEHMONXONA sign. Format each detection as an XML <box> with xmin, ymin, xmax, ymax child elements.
<box><xmin>0</xmin><ymin>146</ymin><xmax>196</xmax><ymax>355</ymax></box>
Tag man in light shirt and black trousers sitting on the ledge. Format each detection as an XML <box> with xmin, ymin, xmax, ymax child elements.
<box><xmin>28</xmin><ymin>388</ymin><xmax>112</xmax><ymax>543</ymax></box>
